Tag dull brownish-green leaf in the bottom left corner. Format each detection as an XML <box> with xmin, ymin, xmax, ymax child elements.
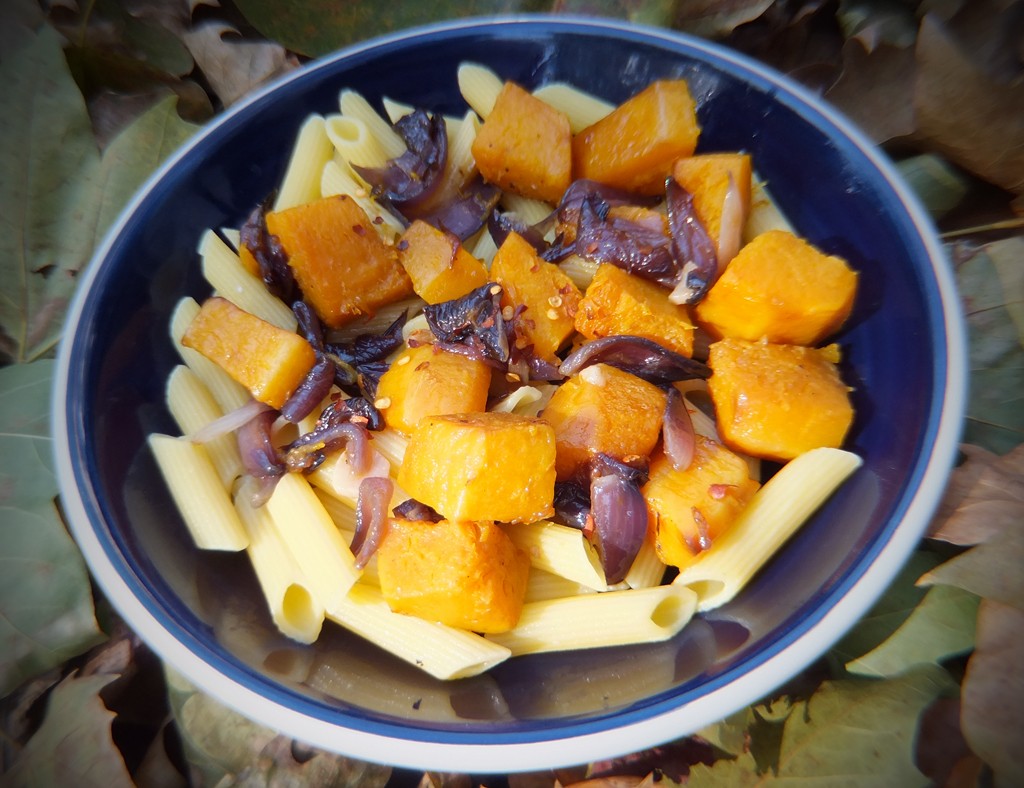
<box><xmin>4</xmin><ymin>675</ymin><xmax>135</xmax><ymax>788</ymax></box>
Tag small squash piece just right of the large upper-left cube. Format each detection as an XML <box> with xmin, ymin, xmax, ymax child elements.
<box><xmin>397</xmin><ymin>219</ymin><xmax>487</xmax><ymax>304</ymax></box>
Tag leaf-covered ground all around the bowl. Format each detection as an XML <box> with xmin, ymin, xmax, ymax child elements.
<box><xmin>0</xmin><ymin>0</ymin><xmax>1024</xmax><ymax>788</ymax></box>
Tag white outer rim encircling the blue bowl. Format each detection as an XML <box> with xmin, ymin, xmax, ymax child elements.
<box><xmin>52</xmin><ymin>14</ymin><xmax>967</xmax><ymax>774</ymax></box>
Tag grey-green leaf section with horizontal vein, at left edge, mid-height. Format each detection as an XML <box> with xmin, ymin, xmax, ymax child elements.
<box><xmin>0</xmin><ymin>359</ymin><xmax>57</xmax><ymax>508</ymax></box>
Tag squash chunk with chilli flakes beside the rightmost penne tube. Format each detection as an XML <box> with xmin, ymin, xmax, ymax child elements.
<box><xmin>641</xmin><ymin>435</ymin><xmax>761</xmax><ymax>568</ymax></box>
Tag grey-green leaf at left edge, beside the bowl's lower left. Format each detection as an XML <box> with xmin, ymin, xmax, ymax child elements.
<box><xmin>0</xmin><ymin>505</ymin><xmax>103</xmax><ymax>697</ymax></box>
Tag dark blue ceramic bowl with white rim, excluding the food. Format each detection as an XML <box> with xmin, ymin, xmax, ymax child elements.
<box><xmin>53</xmin><ymin>17</ymin><xmax>966</xmax><ymax>772</ymax></box>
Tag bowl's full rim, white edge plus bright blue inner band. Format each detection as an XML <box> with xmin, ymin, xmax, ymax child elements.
<box><xmin>53</xmin><ymin>15</ymin><xmax>967</xmax><ymax>773</ymax></box>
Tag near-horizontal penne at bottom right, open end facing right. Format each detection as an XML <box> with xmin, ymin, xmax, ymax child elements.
<box><xmin>486</xmin><ymin>585</ymin><xmax>697</xmax><ymax>656</ymax></box>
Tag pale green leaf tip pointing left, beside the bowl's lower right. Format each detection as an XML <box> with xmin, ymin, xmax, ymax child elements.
<box><xmin>846</xmin><ymin>585</ymin><xmax>980</xmax><ymax>677</ymax></box>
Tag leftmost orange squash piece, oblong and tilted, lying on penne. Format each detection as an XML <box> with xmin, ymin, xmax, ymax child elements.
<box><xmin>181</xmin><ymin>296</ymin><xmax>316</xmax><ymax>408</ymax></box>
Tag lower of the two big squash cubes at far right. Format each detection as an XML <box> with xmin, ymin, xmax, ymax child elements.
<box><xmin>708</xmin><ymin>339</ymin><xmax>853</xmax><ymax>462</ymax></box>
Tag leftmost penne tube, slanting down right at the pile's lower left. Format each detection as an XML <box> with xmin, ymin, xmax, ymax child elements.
<box><xmin>150</xmin><ymin>433</ymin><xmax>249</xmax><ymax>552</ymax></box>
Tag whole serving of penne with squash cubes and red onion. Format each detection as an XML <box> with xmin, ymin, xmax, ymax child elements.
<box><xmin>151</xmin><ymin>63</ymin><xmax>860</xmax><ymax>680</ymax></box>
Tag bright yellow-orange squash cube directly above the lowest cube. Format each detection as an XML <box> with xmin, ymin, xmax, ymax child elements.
<box><xmin>398</xmin><ymin>412</ymin><xmax>555</xmax><ymax>523</ymax></box>
